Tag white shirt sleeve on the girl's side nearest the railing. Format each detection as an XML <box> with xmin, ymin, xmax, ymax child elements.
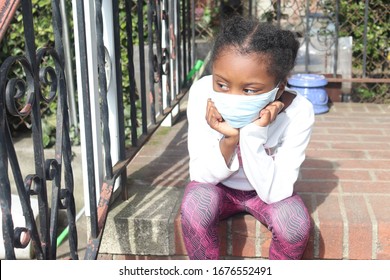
<box><xmin>187</xmin><ymin>76</ymin><xmax>239</xmax><ymax>184</ymax></box>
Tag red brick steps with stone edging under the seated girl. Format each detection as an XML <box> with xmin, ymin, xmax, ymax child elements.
<box><xmin>99</xmin><ymin>101</ymin><xmax>390</xmax><ymax>260</ymax></box>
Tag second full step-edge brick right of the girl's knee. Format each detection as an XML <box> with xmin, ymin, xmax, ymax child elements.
<box><xmin>343</xmin><ymin>196</ymin><xmax>372</xmax><ymax>260</ymax></box>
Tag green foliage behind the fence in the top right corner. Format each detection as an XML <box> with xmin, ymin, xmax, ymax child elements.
<box><xmin>325</xmin><ymin>0</ymin><xmax>390</xmax><ymax>103</ymax></box>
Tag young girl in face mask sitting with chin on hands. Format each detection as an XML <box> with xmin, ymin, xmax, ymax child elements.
<box><xmin>181</xmin><ymin>17</ymin><xmax>314</xmax><ymax>259</ymax></box>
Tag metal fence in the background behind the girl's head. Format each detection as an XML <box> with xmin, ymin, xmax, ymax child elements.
<box><xmin>195</xmin><ymin>0</ymin><xmax>390</xmax><ymax>103</ymax></box>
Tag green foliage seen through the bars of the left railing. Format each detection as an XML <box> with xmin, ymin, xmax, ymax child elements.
<box><xmin>0</xmin><ymin>0</ymin><xmax>148</xmax><ymax>148</ymax></box>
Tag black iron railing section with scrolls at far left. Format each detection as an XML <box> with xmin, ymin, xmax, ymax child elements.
<box><xmin>0</xmin><ymin>1</ymin><xmax>78</xmax><ymax>259</ymax></box>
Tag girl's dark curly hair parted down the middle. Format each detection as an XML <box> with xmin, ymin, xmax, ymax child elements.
<box><xmin>211</xmin><ymin>16</ymin><xmax>299</xmax><ymax>82</ymax></box>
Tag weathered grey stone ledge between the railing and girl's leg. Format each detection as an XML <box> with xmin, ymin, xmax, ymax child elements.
<box><xmin>99</xmin><ymin>186</ymin><xmax>184</xmax><ymax>255</ymax></box>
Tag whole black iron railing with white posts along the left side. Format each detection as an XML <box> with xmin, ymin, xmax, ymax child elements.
<box><xmin>0</xmin><ymin>0</ymin><xmax>194</xmax><ymax>259</ymax></box>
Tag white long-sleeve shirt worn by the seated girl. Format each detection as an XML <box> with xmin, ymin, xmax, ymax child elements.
<box><xmin>187</xmin><ymin>76</ymin><xmax>314</xmax><ymax>203</ymax></box>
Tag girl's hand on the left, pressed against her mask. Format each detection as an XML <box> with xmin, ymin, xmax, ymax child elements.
<box><xmin>206</xmin><ymin>98</ymin><xmax>239</xmax><ymax>137</ymax></box>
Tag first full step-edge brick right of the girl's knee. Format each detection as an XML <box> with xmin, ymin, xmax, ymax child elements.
<box><xmin>316</xmin><ymin>195</ymin><xmax>344</xmax><ymax>259</ymax></box>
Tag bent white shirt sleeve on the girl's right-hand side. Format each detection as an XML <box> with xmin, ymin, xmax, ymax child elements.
<box><xmin>240</xmin><ymin>100</ymin><xmax>314</xmax><ymax>203</ymax></box>
